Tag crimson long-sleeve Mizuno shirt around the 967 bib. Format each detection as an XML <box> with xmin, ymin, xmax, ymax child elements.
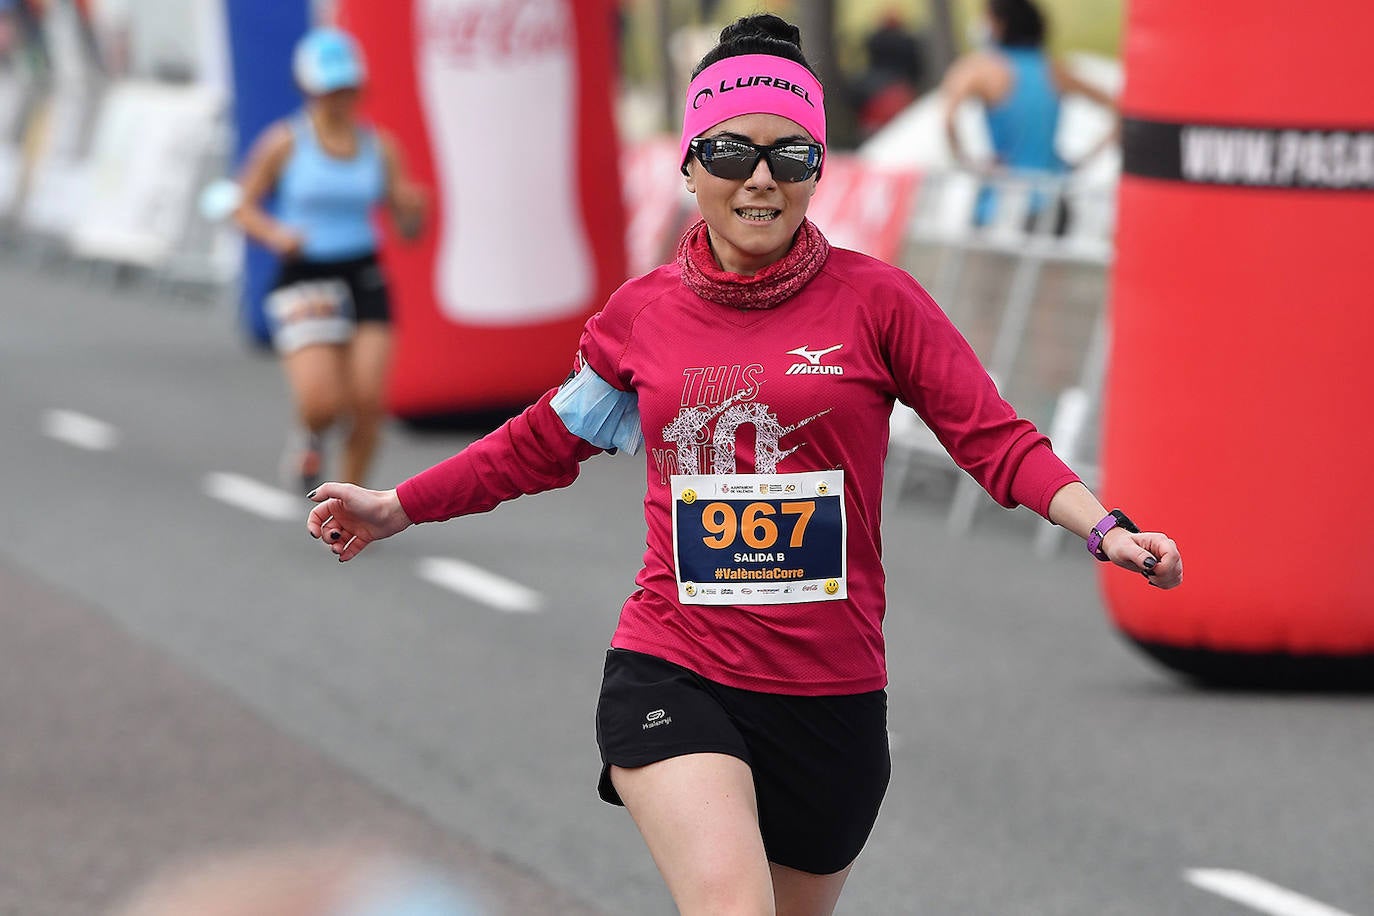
<box><xmin>398</xmin><ymin>249</ymin><xmax>1079</xmax><ymax>695</ymax></box>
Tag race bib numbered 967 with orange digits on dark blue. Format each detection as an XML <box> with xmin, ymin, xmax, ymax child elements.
<box><xmin>669</xmin><ymin>471</ymin><xmax>848</xmax><ymax>604</ymax></box>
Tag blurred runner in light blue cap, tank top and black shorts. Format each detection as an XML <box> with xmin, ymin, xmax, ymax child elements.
<box><xmin>235</xmin><ymin>27</ymin><xmax>427</xmax><ymax>493</ymax></box>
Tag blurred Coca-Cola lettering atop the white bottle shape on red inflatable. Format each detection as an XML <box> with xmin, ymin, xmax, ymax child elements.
<box><xmin>420</xmin><ymin>0</ymin><xmax>569</xmax><ymax>66</ymax></box>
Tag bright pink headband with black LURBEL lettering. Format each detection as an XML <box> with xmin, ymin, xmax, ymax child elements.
<box><xmin>677</xmin><ymin>54</ymin><xmax>826</xmax><ymax>165</ymax></box>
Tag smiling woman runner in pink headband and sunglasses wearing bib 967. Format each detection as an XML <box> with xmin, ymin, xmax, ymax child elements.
<box><xmin>306</xmin><ymin>14</ymin><xmax>1183</xmax><ymax>916</ymax></box>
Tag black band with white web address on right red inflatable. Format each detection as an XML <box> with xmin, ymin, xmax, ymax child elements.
<box><xmin>1121</xmin><ymin>118</ymin><xmax>1374</xmax><ymax>191</ymax></box>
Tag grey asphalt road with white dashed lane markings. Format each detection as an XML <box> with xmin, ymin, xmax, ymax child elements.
<box><xmin>0</xmin><ymin>262</ymin><xmax>1374</xmax><ymax>916</ymax></box>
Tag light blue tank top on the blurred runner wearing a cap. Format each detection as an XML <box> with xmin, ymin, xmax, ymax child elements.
<box><xmin>276</xmin><ymin>114</ymin><xmax>386</xmax><ymax>261</ymax></box>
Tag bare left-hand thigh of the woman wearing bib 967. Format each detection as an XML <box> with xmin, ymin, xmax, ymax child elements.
<box><xmin>610</xmin><ymin>754</ymin><xmax>775</xmax><ymax>916</ymax></box>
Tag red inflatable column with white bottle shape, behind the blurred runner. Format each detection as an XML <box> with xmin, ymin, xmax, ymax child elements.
<box><xmin>338</xmin><ymin>0</ymin><xmax>625</xmax><ymax>420</ymax></box>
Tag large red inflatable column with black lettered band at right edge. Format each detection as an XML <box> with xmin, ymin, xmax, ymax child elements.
<box><xmin>1102</xmin><ymin>0</ymin><xmax>1374</xmax><ymax>688</ymax></box>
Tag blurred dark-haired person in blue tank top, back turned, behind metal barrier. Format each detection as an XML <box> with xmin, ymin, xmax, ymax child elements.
<box><xmin>941</xmin><ymin>0</ymin><xmax>1118</xmax><ymax>232</ymax></box>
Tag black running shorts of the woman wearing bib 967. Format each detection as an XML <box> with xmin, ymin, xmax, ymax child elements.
<box><xmin>596</xmin><ymin>648</ymin><xmax>892</xmax><ymax>875</ymax></box>
